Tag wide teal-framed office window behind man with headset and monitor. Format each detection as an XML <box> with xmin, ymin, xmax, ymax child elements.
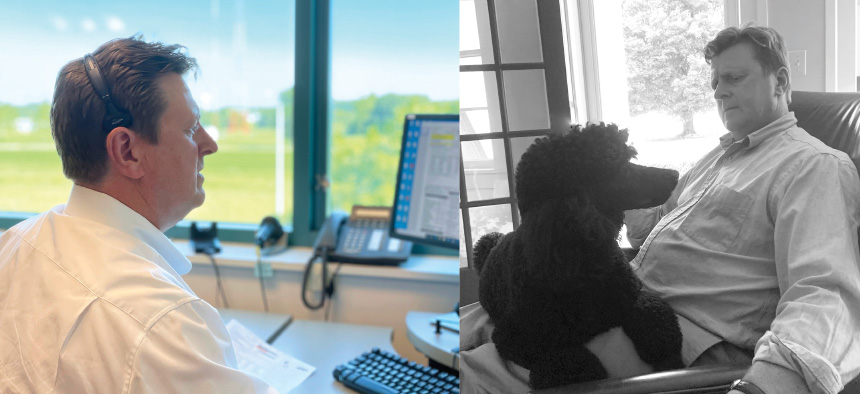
<box><xmin>0</xmin><ymin>0</ymin><xmax>459</xmax><ymax>254</ymax></box>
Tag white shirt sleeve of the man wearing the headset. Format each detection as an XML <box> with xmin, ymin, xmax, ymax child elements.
<box><xmin>125</xmin><ymin>300</ymin><xmax>278</xmax><ymax>394</ymax></box>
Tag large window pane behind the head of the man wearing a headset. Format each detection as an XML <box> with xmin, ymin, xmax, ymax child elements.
<box><xmin>0</xmin><ymin>0</ymin><xmax>295</xmax><ymax>223</ymax></box>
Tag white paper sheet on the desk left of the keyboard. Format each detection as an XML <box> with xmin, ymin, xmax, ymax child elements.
<box><xmin>227</xmin><ymin>319</ymin><xmax>316</xmax><ymax>394</ymax></box>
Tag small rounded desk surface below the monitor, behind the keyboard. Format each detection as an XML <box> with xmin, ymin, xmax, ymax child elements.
<box><xmin>406</xmin><ymin>311</ymin><xmax>460</xmax><ymax>371</ymax></box>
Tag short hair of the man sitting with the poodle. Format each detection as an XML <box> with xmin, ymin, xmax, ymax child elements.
<box><xmin>705</xmin><ymin>24</ymin><xmax>791</xmax><ymax>102</ymax></box>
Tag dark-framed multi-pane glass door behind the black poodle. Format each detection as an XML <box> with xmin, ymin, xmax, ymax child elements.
<box><xmin>460</xmin><ymin>0</ymin><xmax>570</xmax><ymax>266</ymax></box>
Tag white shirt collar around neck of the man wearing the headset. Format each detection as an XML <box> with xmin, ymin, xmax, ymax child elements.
<box><xmin>64</xmin><ymin>185</ymin><xmax>191</xmax><ymax>275</ymax></box>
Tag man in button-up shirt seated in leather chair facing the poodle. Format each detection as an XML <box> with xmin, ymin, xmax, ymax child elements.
<box><xmin>625</xmin><ymin>26</ymin><xmax>860</xmax><ymax>394</ymax></box>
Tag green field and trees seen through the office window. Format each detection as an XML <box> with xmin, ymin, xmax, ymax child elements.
<box><xmin>0</xmin><ymin>92</ymin><xmax>459</xmax><ymax>224</ymax></box>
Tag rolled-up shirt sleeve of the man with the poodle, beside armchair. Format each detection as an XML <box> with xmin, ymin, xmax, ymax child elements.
<box><xmin>753</xmin><ymin>154</ymin><xmax>860</xmax><ymax>394</ymax></box>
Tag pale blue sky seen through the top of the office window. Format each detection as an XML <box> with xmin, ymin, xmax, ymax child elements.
<box><xmin>0</xmin><ymin>0</ymin><xmax>459</xmax><ymax>109</ymax></box>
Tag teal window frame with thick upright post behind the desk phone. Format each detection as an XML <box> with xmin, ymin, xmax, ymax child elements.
<box><xmin>0</xmin><ymin>0</ymin><xmax>457</xmax><ymax>256</ymax></box>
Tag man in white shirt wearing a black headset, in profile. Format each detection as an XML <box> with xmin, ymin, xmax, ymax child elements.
<box><xmin>0</xmin><ymin>38</ymin><xmax>275</xmax><ymax>393</ymax></box>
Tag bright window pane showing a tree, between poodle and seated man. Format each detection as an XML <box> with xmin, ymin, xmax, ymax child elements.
<box><xmin>576</xmin><ymin>0</ymin><xmax>727</xmax><ymax>172</ymax></box>
